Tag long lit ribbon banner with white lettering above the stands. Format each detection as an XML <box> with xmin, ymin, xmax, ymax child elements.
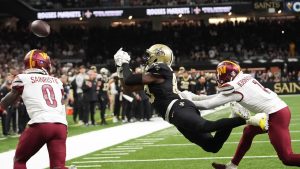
<box><xmin>37</xmin><ymin>3</ymin><xmax>252</xmax><ymax>20</ymax></box>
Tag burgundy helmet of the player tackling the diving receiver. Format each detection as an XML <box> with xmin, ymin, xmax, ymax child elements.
<box><xmin>216</xmin><ymin>60</ymin><xmax>241</xmax><ymax>85</ymax></box>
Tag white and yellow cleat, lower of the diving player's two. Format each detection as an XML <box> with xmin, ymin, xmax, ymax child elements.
<box><xmin>247</xmin><ymin>113</ymin><xmax>269</xmax><ymax>131</ymax></box>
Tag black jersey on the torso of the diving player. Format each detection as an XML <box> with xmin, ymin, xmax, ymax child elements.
<box><xmin>145</xmin><ymin>63</ymin><xmax>180</xmax><ymax>118</ymax></box>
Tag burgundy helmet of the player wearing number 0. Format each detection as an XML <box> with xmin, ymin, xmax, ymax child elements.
<box><xmin>24</xmin><ymin>49</ymin><xmax>51</xmax><ymax>73</ymax></box>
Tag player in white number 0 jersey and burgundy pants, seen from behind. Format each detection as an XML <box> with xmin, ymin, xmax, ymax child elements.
<box><xmin>0</xmin><ymin>50</ymin><xmax>67</xmax><ymax>169</ymax></box>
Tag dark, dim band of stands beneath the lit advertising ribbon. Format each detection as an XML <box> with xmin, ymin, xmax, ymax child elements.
<box><xmin>0</xmin><ymin>19</ymin><xmax>300</xmax><ymax>67</ymax></box>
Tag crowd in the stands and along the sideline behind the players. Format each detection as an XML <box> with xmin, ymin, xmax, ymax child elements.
<box><xmin>0</xmin><ymin>20</ymin><xmax>300</xmax><ymax>135</ymax></box>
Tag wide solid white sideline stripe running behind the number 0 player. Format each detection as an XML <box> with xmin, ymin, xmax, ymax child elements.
<box><xmin>0</xmin><ymin>118</ymin><xmax>172</xmax><ymax>169</ymax></box>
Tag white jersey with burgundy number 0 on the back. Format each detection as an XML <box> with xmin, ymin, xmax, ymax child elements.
<box><xmin>17</xmin><ymin>74</ymin><xmax>67</xmax><ymax>125</ymax></box>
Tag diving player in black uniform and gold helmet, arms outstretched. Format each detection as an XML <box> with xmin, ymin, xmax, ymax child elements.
<box><xmin>114</xmin><ymin>44</ymin><xmax>268</xmax><ymax>153</ymax></box>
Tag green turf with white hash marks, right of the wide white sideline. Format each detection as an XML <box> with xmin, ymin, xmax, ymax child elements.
<box><xmin>67</xmin><ymin>96</ymin><xmax>300</xmax><ymax>169</ymax></box>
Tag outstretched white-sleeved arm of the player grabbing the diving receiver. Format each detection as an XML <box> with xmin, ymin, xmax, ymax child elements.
<box><xmin>193</xmin><ymin>93</ymin><xmax>242</xmax><ymax>110</ymax></box>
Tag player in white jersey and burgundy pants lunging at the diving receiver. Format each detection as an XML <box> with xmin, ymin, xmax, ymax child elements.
<box><xmin>179</xmin><ymin>61</ymin><xmax>300</xmax><ymax>169</ymax></box>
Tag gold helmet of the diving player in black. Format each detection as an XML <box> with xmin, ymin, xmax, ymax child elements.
<box><xmin>146</xmin><ymin>44</ymin><xmax>174</xmax><ymax>66</ymax></box>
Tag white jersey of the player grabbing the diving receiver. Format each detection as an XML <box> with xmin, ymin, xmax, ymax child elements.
<box><xmin>228</xmin><ymin>73</ymin><xmax>287</xmax><ymax>114</ymax></box>
